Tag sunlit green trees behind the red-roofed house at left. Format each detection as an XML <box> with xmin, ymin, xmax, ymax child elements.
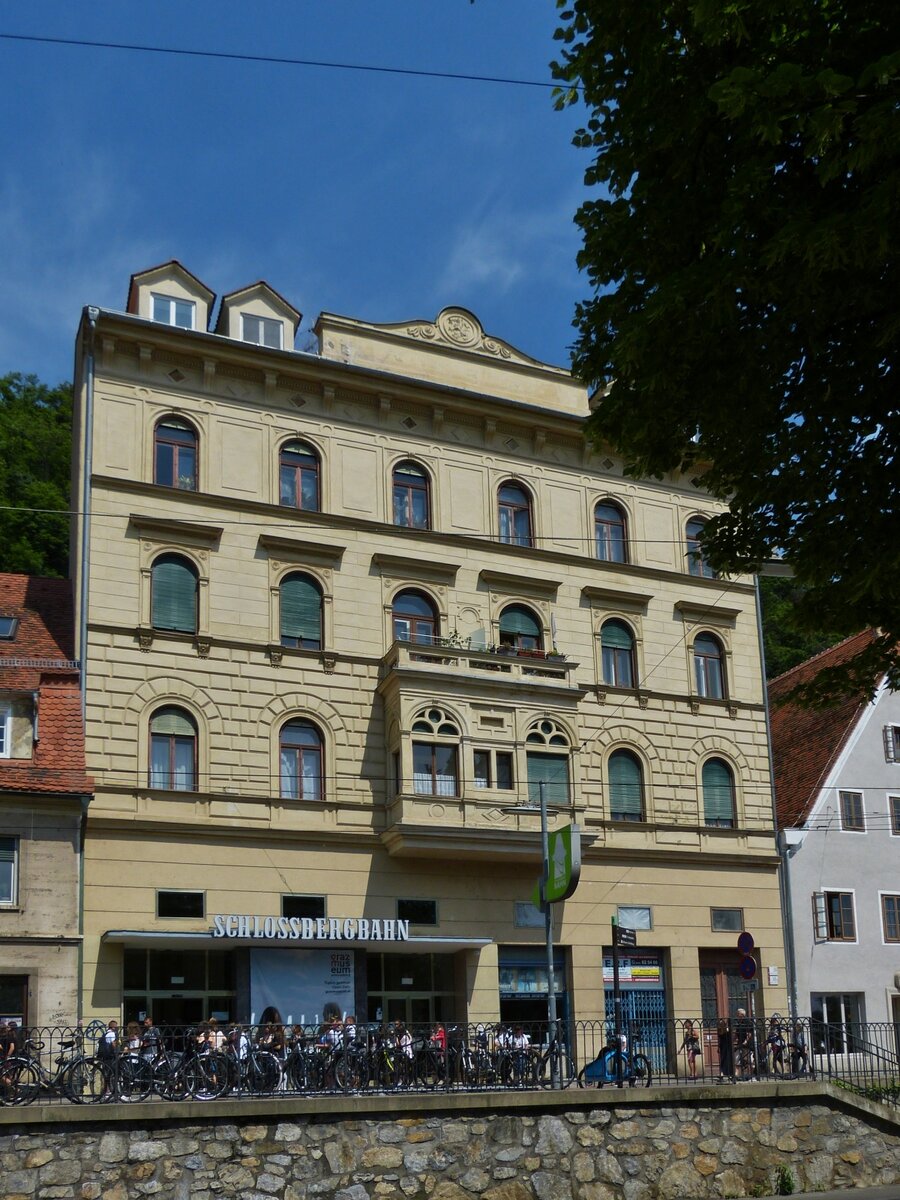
<box><xmin>0</xmin><ymin>374</ymin><xmax>72</xmax><ymax>576</ymax></box>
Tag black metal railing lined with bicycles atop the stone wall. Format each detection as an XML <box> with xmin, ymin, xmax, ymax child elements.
<box><xmin>0</xmin><ymin>1018</ymin><xmax>900</xmax><ymax>1105</ymax></box>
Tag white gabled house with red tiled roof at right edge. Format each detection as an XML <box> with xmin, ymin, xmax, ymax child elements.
<box><xmin>769</xmin><ymin>630</ymin><xmax>900</xmax><ymax>1052</ymax></box>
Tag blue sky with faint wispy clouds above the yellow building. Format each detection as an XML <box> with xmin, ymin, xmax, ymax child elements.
<box><xmin>0</xmin><ymin>0</ymin><xmax>587</xmax><ymax>383</ymax></box>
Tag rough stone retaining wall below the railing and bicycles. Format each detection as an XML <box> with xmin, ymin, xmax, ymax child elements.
<box><xmin>0</xmin><ymin>1085</ymin><xmax>900</xmax><ymax>1200</ymax></box>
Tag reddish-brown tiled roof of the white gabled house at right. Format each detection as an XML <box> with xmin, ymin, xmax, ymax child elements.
<box><xmin>769</xmin><ymin>629</ymin><xmax>877</xmax><ymax>829</ymax></box>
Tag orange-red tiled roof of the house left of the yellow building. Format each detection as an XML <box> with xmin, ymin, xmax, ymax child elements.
<box><xmin>0</xmin><ymin>575</ymin><xmax>92</xmax><ymax>794</ymax></box>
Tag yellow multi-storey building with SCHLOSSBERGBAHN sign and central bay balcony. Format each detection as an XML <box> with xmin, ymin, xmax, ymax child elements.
<box><xmin>73</xmin><ymin>263</ymin><xmax>786</xmax><ymax>1022</ymax></box>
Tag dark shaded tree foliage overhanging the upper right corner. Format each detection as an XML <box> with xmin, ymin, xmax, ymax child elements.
<box><xmin>553</xmin><ymin>0</ymin><xmax>900</xmax><ymax>689</ymax></box>
